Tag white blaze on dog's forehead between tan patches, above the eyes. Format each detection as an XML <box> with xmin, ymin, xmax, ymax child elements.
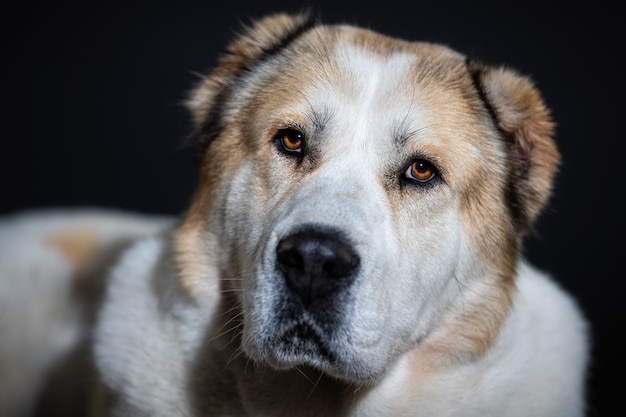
<box><xmin>306</xmin><ymin>43</ymin><xmax>422</xmax><ymax>158</ymax></box>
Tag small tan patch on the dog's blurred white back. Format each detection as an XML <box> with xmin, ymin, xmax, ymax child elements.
<box><xmin>45</xmin><ymin>228</ymin><xmax>98</xmax><ymax>285</ymax></box>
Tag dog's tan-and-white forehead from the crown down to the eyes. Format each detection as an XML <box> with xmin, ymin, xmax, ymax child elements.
<box><xmin>246</xmin><ymin>27</ymin><xmax>492</xmax><ymax>170</ymax></box>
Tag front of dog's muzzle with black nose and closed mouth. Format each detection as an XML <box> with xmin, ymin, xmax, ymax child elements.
<box><xmin>242</xmin><ymin>222</ymin><xmax>388</xmax><ymax>381</ymax></box>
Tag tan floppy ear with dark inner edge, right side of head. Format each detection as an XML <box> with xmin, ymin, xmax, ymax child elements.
<box><xmin>472</xmin><ymin>65</ymin><xmax>560</xmax><ymax>232</ymax></box>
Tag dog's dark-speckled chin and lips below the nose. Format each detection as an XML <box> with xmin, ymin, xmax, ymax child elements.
<box><xmin>244</xmin><ymin>324</ymin><xmax>383</xmax><ymax>384</ymax></box>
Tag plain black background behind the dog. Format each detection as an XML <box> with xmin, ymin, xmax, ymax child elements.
<box><xmin>0</xmin><ymin>0</ymin><xmax>626</xmax><ymax>416</ymax></box>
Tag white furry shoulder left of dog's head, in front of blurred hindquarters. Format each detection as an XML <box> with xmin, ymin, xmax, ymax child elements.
<box><xmin>92</xmin><ymin>224</ymin><xmax>219</xmax><ymax>416</ymax></box>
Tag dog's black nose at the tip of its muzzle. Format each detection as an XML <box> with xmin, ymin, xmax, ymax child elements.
<box><xmin>276</xmin><ymin>230</ymin><xmax>359</xmax><ymax>304</ymax></box>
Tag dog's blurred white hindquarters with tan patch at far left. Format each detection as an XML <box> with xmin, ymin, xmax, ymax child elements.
<box><xmin>0</xmin><ymin>208</ymin><xmax>174</xmax><ymax>416</ymax></box>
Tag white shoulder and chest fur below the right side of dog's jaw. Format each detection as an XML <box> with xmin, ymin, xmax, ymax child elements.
<box><xmin>383</xmin><ymin>260</ymin><xmax>589</xmax><ymax>417</ymax></box>
